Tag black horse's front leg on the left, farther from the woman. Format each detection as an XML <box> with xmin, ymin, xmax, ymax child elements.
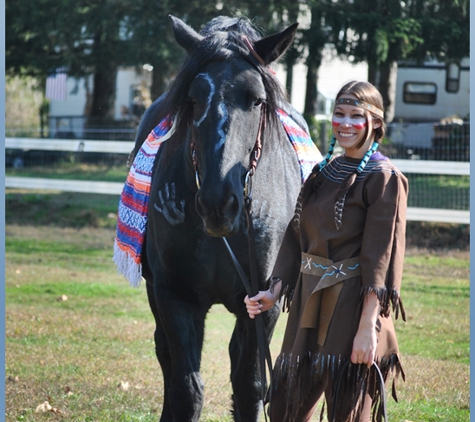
<box><xmin>155</xmin><ymin>278</ymin><xmax>207</xmax><ymax>422</ymax></box>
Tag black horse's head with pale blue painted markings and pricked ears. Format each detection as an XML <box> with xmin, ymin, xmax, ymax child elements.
<box><xmin>168</xmin><ymin>16</ymin><xmax>297</xmax><ymax>236</ymax></box>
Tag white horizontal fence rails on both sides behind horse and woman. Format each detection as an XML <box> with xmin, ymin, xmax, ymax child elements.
<box><xmin>5</xmin><ymin>138</ymin><xmax>470</xmax><ymax>224</ymax></box>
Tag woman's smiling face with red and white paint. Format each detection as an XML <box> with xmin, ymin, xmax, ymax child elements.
<box><xmin>332</xmin><ymin>94</ymin><xmax>373</xmax><ymax>158</ymax></box>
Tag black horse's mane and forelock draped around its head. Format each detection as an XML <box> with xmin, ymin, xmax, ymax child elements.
<box><xmin>158</xmin><ymin>16</ymin><xmax>287</xmax><ymax>152</ymax></box>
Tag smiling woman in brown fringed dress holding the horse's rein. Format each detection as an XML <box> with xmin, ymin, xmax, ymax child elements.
<box><xmin>244</xmin><ymin>81</ymin><xmax>408</xmax><ymax>422</ymax></box>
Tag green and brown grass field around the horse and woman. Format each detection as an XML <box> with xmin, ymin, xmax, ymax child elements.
<box><xmin>5</xmin><ymin>192</ymin><xmax>469</xmax><ymax>422</ymax></box>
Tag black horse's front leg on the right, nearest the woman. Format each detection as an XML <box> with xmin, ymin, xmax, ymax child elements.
<box><xmin>229</xmin><ymin>307</ymin><xmax>279</xmax><ymax>422</ymax></box>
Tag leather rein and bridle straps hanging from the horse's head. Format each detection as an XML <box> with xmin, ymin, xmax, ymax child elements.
<box><xmin>190</xmin><ymin>105</ymin><xmax>272</xmax><ymax>421</ymax></box>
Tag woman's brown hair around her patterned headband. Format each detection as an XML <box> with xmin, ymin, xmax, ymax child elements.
<box><xmin>336</xmin><ymin>81</ymin><xmax>386</xmax><ymax>148</ymax></box>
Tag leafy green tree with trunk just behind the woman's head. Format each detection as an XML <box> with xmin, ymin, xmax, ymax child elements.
<box><xmin>327</xmin><ymin>0</ymin><xmax>469</xmax><ymax>122</ymax></box>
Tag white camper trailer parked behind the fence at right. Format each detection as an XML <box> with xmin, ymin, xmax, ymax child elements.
<box><xmin>388</xmin><ymin>58</ymin><xmax>470</xmax><ymax>160</ymax></box>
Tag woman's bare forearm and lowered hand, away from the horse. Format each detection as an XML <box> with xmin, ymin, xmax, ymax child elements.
<box><xmin>351</xmin><ymin>292</ymin><xmax>379</xmax><ymax>368</ymax></box>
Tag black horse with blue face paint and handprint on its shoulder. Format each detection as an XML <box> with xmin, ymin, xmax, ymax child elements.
<box><xmin>131</xmin><ymin>17</ymin><xmax>320</xmax><ymax>422</ymax></box>
